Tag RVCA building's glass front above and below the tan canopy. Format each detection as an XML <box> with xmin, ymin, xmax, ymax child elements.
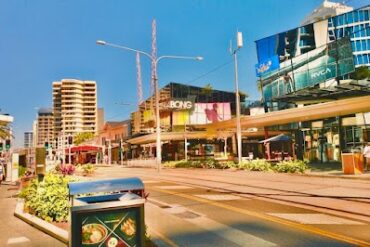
<box><xmin>256</xmin><ymin>6</ymin><xmax>370</xmax><ymax>161</ymax></box>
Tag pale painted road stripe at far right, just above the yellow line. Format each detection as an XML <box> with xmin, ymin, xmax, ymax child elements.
<box><xmin>269</xmin><ymin>213</ymin><xmax>366</xmax><ymax>225</ymax></box>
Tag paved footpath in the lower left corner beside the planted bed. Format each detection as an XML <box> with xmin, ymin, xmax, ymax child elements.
<box><xmin>0</xmin><ymin>185</ymin><xmax>66</xmax><ymax>247</ymax></box>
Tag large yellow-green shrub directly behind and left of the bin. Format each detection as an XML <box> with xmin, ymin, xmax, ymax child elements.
<box><xmin>19</xmin><ymin>173</ymin><xmax>74</xmax><ymax>222</ymax></box>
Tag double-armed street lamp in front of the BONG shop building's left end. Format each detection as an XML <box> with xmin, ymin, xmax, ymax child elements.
<box><xmin>96</xmin><ymin>40</ymin><xmax>203</xmax><ymax>172</ymax></box>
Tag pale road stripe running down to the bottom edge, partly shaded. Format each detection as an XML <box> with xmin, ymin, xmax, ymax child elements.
<box><xmin>186</xmin><ymin>217</ymin><xmax>276</xmax><ymax>247</ymax></box>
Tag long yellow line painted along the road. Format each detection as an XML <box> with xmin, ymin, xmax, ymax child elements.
<box><xmin>153</xmin><ymin>188</ymin><xmax>370</xmax><ymax>247</ymax></box>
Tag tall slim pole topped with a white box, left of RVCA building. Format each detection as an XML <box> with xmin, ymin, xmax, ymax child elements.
<box><xmin>230</xmin><ymin>32</ymin><xmax>243</xmax><ymax>164</ymax></box>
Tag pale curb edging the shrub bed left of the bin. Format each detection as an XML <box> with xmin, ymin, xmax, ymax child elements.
<box><xmin>14</xmin><ymin>200</ymin><xmax>69</xmax><ymax>244</ymax></box>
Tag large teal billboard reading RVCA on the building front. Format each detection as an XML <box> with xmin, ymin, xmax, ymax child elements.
<box><xmin>263</xmin><ymin>38</ymin><xmax>355</xmax><ymax>99</ymax></box>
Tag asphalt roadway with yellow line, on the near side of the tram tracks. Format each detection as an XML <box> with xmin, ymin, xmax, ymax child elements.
<box><xmin>94</xmin><ymin>168</ymin><xmax>370</xmax><ymax>247</ymax></box>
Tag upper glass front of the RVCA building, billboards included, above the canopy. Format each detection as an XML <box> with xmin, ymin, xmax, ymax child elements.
<box><xmin>256</xmin><ymin>6</ymin><xmax>370</xmax><ymax>101</ymax></box>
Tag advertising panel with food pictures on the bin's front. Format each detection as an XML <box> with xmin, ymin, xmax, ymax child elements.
<box><xmin>79</xmin><ymin>207</ymin><xmax>142</xmax><ymax>247</ymax></box>
